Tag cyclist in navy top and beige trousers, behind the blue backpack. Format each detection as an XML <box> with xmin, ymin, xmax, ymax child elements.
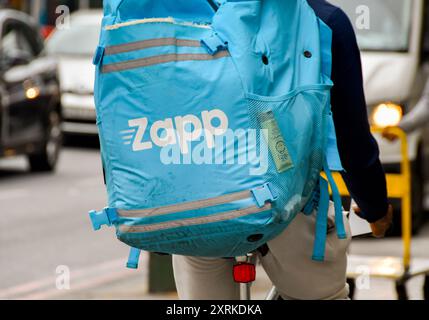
<box><xmin>173</xmin><ymin>0</ymin><xmax>392</xmax><ymax>300</ymax></box>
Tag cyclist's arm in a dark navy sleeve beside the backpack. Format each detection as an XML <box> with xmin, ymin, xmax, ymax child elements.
<box><xmin>328</xmin><ymin>9</ymin><xmax>389</xmax><ymax>223</ymax></box>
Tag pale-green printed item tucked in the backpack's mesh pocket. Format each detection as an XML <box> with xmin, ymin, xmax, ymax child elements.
<box><xmin>258</xmin><ymin>111</ymin><xmax>293</xmax><ymax>173</ymax></box>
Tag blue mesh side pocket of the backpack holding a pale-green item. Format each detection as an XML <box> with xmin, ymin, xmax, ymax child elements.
<box><xmin>248</xmin><ymin>90</ymin><xmax>329</xmax><ymax>222</ymax></box>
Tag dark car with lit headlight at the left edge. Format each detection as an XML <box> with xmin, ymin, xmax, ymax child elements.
<box><xmin>0</xmin><ymin>9</ymin><xmax>61</xmax><ymax>171</ymax></box>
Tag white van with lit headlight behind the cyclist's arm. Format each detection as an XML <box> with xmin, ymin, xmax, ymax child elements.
<box><xmin>332</xmin><ymin>0</ymin><xmax>429</xmax><ymax>231</ymax></box>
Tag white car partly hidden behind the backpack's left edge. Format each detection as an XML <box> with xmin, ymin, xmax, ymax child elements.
<box><xmin>46</xmin><ymin>10</ymin><xmax>103</xmax><ymax>135</ymax></box>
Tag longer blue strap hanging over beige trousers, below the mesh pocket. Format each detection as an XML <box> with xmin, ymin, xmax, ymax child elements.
<box><xmin>313</xmin><ymin>177</ymin><xmax>329</xmax><ymax>261</ymax></box>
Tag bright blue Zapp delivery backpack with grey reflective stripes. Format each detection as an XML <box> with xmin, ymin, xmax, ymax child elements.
<box><xmin>90</xmin><ymin>0</ymin><xmax>346</xmax><ymax>268</ymax></box>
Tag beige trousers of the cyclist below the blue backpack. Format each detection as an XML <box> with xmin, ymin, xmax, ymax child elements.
<box><xmin>173</xmin><ymin>203</ymin><xmax>351</xmax><ymax>300</ymax></box>
